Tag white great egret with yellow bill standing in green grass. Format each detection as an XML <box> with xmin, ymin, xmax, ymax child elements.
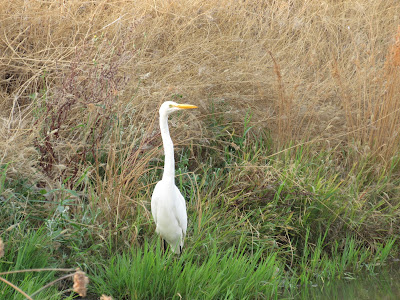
<box><xmin>151</xmin><ymin>101</ymin><xmax>197</xmax><ymax>254</ymax></box>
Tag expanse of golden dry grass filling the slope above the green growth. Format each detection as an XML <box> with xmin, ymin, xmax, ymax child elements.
<box><xmin>0</xmin><ymin>0</ymin><xmax>400</xmax><ymax>183</ymax></box>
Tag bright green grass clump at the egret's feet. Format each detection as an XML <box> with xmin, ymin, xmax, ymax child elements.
<box><xmin>91</xmin><ymin>243</ymin><xmax>280</xmax><ymax>299</ymax></box>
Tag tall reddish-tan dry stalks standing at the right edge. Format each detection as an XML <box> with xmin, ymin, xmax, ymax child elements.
<box><xmin>334</xmin><ymin>27</ymin><xmax>400</xmax><ymax>165</ymax></box>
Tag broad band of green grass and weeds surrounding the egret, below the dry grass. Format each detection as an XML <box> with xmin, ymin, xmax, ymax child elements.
<box><xmin>0</xmin><ymin>109</ymin><xmax>400</xmax><ymax>299</ymax></box>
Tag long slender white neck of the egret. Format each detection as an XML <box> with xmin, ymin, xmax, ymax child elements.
<box><xmin>160</xmin><ymin>114</ymin><xmax>175</xmax><ymax>181</ymax></box>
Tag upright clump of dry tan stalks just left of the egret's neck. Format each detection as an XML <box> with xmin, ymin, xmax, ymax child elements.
<box><xmin>93</xmin><ymin>102</ymin><xmax>159</xmax><ymax>224</ymax></box>
